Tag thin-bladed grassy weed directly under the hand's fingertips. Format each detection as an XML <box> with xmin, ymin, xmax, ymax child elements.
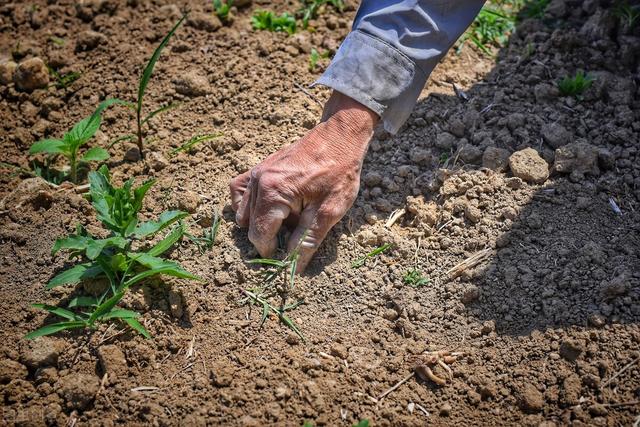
<box><xmin>243</xmin><ymin>244</ymin><xmax>305</xmax><ymax>342</ymax></box>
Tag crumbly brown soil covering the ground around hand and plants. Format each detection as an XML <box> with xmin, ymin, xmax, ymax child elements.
<box><xmin>0</xmin><ymin>0</ymin><xmax>640</xmax><ymax>426</ymax></box>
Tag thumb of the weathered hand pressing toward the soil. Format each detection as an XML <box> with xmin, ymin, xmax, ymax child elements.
<box><xmin>288</xmin><ymin>205</ymin><xmax>344</xmax><ymax>273</ymax></box>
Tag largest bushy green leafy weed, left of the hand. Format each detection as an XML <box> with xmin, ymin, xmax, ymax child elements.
<box><xmin>26</xmin><ymin>166</ymin><xmax>201</xmax><ymax>339</ymax></box>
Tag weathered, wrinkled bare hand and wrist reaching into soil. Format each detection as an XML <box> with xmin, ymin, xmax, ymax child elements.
<box><xmin>230</xmin><ymin>92</ymin><xmax>378</xmax><ymax>272</ymax></box>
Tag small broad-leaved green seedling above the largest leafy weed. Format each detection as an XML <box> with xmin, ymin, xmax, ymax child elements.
<box><xmin>29</xmin><ymin>99</ymin><xmax>123</xmax><ymax>184</ymax></box>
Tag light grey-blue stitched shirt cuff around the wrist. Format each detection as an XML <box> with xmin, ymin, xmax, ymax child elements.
<box><xmin>313</xmin><ymin>30</ymin><xmax>431</xmax><ymax>134</ymax></box>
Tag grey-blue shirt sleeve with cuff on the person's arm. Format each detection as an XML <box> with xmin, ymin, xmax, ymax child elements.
<box><xmin>314</xmin><ymin>0</ymin><xmax>484</xmax><ymax>133</ymax></box>
